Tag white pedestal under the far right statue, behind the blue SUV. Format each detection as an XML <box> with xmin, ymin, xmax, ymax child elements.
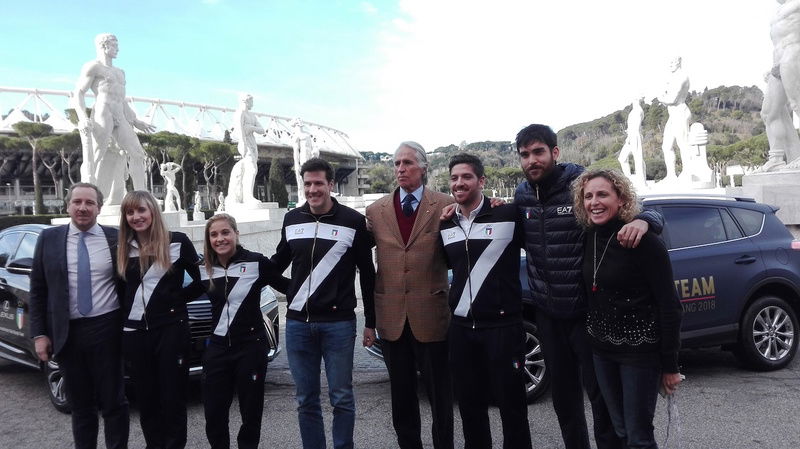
<box><xmin>727</xmin><ymin>170</ymin><xmax>800</xmax><ymax>229</ymax></box>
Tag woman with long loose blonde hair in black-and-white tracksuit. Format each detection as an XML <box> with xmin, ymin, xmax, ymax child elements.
<box><xmin>117</xmin><ymin>191</ymin><xmax>202</xmax><ymax>448</ymax></box>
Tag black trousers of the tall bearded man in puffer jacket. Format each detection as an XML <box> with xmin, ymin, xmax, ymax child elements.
<box><xmin>536</xmin><ymin>313</ymin><xmax>624</xmax><ymax>449</ymax></box>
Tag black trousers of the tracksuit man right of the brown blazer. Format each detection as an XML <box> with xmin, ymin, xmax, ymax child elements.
<box><xmin>448</xmin><ymin>323</ymin><xmax>531</xmax><ymax>449</ymax></box>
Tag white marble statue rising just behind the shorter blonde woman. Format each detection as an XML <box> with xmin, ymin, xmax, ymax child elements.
<box><xmin>225</xmin><ymin>94</ymin><xmax>264</xmax><ymax>210</ymax></box>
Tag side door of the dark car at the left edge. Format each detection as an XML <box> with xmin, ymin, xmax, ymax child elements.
<box><xmin>0</xmin><ymin>232</ymin><xmax>28</xmax><ymax>358</ymax></box>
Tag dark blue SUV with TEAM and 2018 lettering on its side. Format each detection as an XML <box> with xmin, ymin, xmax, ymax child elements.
<box><xmin>368</xmin><ymin>195</ymin><xmax>800</xmax><ymax>402</ymax></box>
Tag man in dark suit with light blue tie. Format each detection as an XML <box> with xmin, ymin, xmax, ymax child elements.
<box><xmin>30</xmin><ymin>183</ymin><xmax>129</xmax><ymax>449</ymax></box>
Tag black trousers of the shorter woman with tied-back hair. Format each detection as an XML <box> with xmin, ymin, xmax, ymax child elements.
<box><xmin>203</xmin><ymin>337</ymin><xmax>269</xmax><ymax>449</ymax></box>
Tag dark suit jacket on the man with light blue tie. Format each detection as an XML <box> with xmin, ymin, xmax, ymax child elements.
<box><xmin>29</xmin><ymin>225</ymin><xmax>121</xmax><ymax>355</ymax></box>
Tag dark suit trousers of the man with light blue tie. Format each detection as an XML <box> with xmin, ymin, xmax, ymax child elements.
<box><xmin>56</xmin><ymin>310</ymin><xmax>129</xmax><ymax>449</ymax></box>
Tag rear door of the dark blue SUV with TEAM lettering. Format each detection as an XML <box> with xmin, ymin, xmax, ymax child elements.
<box><xmin>661</xmin><ymin>205</ymin><xmax>764</xmax><ymax>339</ymax></box>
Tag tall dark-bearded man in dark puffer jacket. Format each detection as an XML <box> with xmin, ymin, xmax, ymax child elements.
<box><xmin>514</xmin><ymin>124</ymin><xmax>663</xmax><ymax>449</ymax></box>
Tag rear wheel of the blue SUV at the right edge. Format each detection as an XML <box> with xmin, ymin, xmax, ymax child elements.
<box><xmin>735</xmin><ymin>296</ymin><xmax>800</xmax><ymax>371</ymax></box>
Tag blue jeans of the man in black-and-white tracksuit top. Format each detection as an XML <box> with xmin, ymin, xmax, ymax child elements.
<box><xmin>286</xmin><ymin>319</ymin><xmax>356</xmax><ymax>449</ymax></box>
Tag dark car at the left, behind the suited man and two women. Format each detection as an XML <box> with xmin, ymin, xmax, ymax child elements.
<box><xmin>0</xmin><ymin>224</ymin><xmax>281</xmax><ymax>412</ymax></box>
